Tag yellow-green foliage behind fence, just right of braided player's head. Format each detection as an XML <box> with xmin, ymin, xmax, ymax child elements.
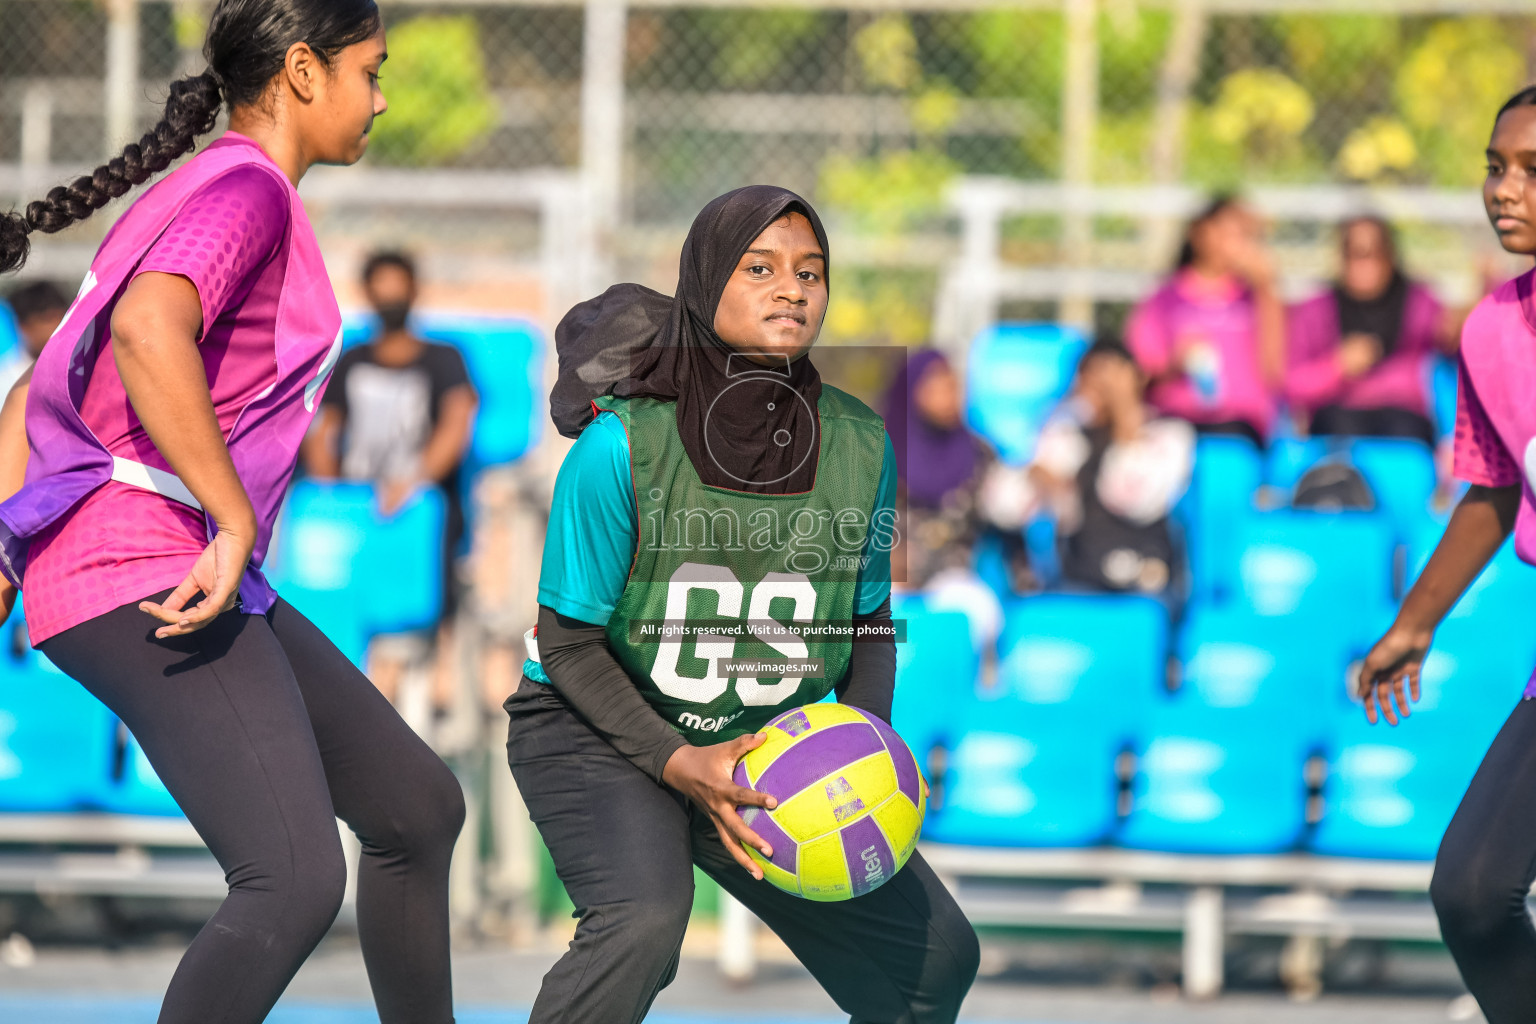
<box><xmin>370</xmin><ymin>15</ymin><xmax>498</xmax><ymax>166</ymax></box>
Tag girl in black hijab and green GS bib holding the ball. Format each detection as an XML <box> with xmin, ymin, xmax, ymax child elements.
<box><xmin>505</xmin><ymin>186</ymin><xmax>978</xmax><ymax>1024</ymax></box>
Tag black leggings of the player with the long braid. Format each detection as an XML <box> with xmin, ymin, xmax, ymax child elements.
<box><xmin>41</xmin><ymin>597</ymin><xmax>464</xmax><ymax>1024</ymax></box>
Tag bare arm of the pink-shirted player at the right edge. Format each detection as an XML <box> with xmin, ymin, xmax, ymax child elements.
<box><xmin>1356</xmin><ymin>484</ymin><xmax>1521</xmax><ymax>725</ymax></box>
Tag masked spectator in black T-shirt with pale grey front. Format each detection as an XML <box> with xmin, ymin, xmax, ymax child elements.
<box><xmin>303</xmin><ymin>252</ymin><xmax>478</xmax><ymax>697</ymax></box>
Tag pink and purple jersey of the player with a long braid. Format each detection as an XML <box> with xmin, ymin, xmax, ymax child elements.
<box><xmin>0</xmin><ymin>134</ymin><xmax>341</xmax><ymax>643</ymax></box>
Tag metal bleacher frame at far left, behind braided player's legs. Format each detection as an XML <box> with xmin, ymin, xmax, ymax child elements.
<box><xmin>0</xmin><ymin>812</ymin><xmax>227</xmax><ymax>900</ymax></box>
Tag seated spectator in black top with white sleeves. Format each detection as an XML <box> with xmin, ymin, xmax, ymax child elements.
<box><xmin>1028</xmin><ymin>339</ymin><xmax>1195</xmax><ymax>594</ymax></box>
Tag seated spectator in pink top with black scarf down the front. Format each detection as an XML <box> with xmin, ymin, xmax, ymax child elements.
<box><xmin>1286</xmin><ymin>216</ymin><xmax>1455</xmax><ymax>445</ymax></box>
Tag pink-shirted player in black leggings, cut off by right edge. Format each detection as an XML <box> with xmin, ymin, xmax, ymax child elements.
<box><xmin>1356</xmin><ymin>88</ymin><xmax>1536</xmax><ymax>1024</ymax></box>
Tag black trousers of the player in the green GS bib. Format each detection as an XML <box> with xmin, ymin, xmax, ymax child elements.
<box><xmin>507</xmin><ymin>679</ymin><xmax>980</xmax><ymax>1024</ymax></box>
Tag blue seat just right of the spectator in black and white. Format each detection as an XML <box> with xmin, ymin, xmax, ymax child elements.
<box><xmin>1180</xmin><ymin>436</ymin><xmax>1263</xmax><ymax>599</ymax></box>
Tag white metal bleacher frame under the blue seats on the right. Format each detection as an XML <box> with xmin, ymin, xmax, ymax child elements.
<box><xmin>920</xmin><ymin>843</ymin><xmax>1439</xmax><ymax>998</ymax></box>
